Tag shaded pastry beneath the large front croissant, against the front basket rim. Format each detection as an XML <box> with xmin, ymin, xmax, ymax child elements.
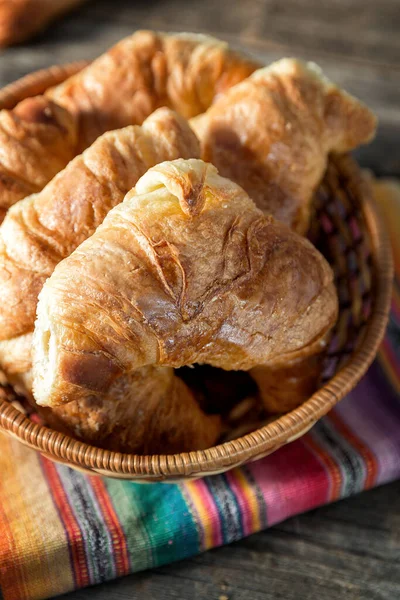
<box><xmin>35</xmin><ymin>366</ymin><xmax>221</xmax><ymax>454</ymax></box>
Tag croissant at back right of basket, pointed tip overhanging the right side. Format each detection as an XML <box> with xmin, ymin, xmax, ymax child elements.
<box><xmin>191</xmin><ymin>59</ymin><xmax>376</xmax><ymax>234</ymax></box>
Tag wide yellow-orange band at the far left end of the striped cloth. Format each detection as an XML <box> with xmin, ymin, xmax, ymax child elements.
<box><xmin>0</xmin><ymin>436</ymin><xmax>74</xmax><ymax>600</ymax></box>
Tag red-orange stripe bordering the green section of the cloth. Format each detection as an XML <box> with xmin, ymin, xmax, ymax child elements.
<box><xmin>90</xmin><ymin>475</ymin><xmax>130</xmax><ymax>577</ymax></box>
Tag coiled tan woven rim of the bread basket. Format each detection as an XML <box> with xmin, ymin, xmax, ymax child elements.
<box><xmin>0</xmin><ymin>61</ymin><xmax>393</xmax><ymax>478</ymax></box>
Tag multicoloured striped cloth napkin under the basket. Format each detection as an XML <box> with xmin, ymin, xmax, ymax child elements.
<box><xmin>0</xmin><ymin>178</ymin><xmax>400</xmax><ymax>600</ymax></box>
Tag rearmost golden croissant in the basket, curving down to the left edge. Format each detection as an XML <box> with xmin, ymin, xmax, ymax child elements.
<box><xmin>0</xmin><ymin>32</ymin><xmax>260</xmax><ymax>216</ymax></box>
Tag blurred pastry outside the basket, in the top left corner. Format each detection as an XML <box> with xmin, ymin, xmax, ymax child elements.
<box><xmin>0</xmin><ymin>0</ymin><xmax>83</xmax><ymax>46</ymax></box>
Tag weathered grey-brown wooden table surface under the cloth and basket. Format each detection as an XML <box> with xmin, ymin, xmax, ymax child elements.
<box><xmin>0</xmin><ymin>0</ymin><xmax>400</xmax><ymax>600</ymax></box>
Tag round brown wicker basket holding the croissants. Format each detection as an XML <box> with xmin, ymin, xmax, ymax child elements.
<box><xmin>0</xmin><ymin>63</ymin><xmax>392</xmax><ymax>482</ymax></box>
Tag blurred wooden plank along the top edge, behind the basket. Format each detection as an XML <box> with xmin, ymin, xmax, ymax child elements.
<box><xmin>71</xmin><ymin>0</ymin><xmax>400</xmax><ymax>68</ymax></box>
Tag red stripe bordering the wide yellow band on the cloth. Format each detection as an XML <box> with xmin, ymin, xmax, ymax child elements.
<box><xmin>40</xmin><ymin>457</ymin><xmax>90</xmax><ymax>588</ymax></box>
